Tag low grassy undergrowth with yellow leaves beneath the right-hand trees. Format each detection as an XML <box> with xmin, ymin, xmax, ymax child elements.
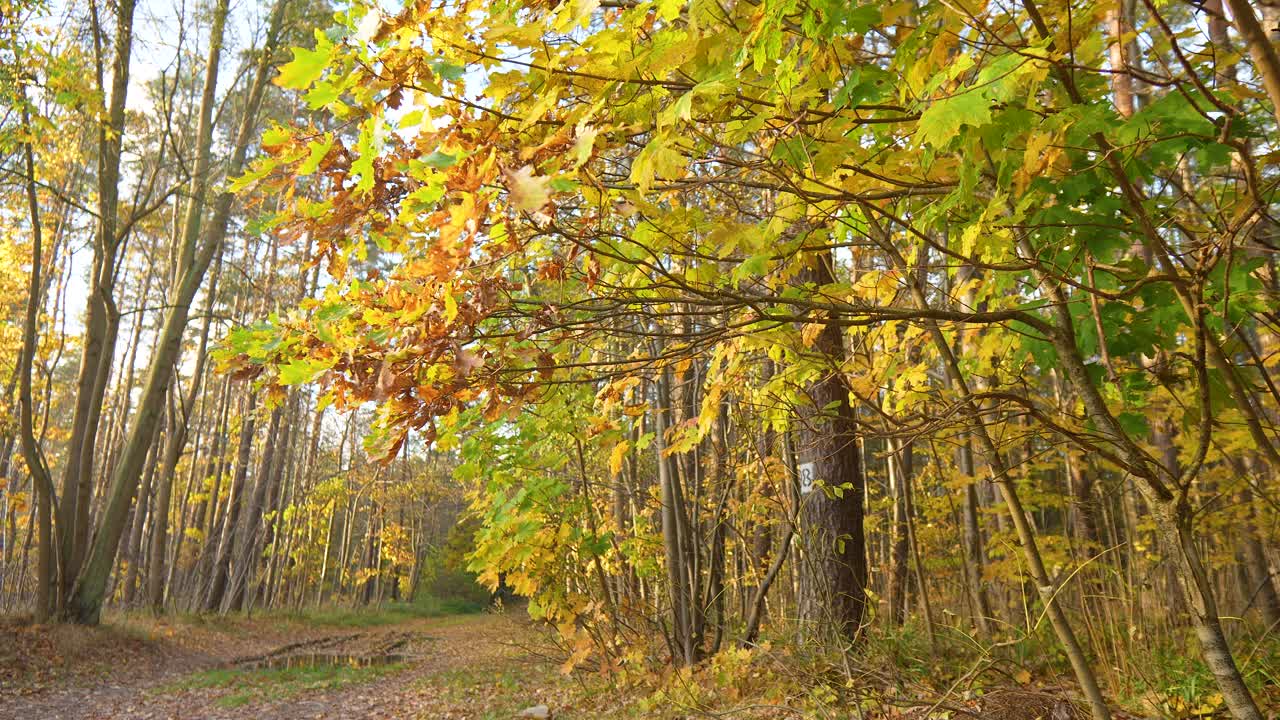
<box><xmin>550</xmin><ymin>614</ymin><xmax>1280</xmax><ymax>720</ymax></box>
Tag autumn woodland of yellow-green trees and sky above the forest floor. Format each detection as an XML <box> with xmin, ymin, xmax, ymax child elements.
<box><xmin>0</xmin><ymin>0</ymin><xmax>1280</xmax><ymax>720</ymax></box>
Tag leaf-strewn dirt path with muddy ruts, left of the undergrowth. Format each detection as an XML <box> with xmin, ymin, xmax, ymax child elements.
<box><xmin>0</xmin><ymin>611</ymin><xmax>572</xmax><ymax>720</ymax></box>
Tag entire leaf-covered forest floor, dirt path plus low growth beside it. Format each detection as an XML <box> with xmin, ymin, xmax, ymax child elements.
<box><xmin>0</xmin><ymin>609</ymin><xmax>1198</xmax><ymax>720</ymax></box>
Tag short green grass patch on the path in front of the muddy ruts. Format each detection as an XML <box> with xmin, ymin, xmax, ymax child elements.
<box><xmin>161</xmin><ymin>664</ymin><xmax>404</xmax><ymax>708</ymax></box>
